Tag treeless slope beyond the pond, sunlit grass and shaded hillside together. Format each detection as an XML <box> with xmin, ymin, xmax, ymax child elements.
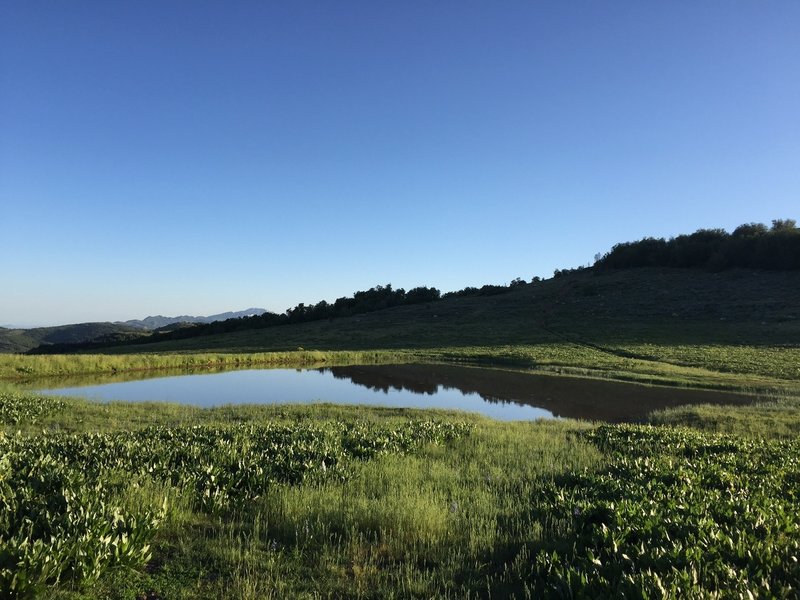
<box><xmin>9</xmin><ymin>269</ymin><xmax>800</xmax><ymax>394</ymax></box>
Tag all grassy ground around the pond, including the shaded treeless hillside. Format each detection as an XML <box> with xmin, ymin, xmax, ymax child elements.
<box><xmin>0</xmin><ymin>270</ymin><xmax>800</xmax><ymax>600</ymax></box>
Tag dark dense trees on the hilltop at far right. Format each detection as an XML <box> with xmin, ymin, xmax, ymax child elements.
<box><xmin>594</xmin><ymin>219</ymin><xmax>800</xmax><ymax>271</ymax></box>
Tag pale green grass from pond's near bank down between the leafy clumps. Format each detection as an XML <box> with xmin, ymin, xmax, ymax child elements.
<box><xmin>0</xmin><ymin>392</ymin><xmax>599</xmax><ymax>598</ymax></box>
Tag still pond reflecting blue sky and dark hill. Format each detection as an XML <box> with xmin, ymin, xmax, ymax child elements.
<box><xmin>34</xmin><ymin>364</ymin><xmax>753</xmax><ymax>422</ymax></box>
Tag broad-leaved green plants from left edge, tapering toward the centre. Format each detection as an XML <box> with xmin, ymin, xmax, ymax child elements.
<box><xmin>0</xmin><ymin>420</ymin><xmax>470</xmax><ymax>597</ymax></box>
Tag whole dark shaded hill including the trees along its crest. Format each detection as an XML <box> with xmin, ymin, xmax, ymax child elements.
<box><xmin>17</xmin><ymin>219</ymin><xmax>800</xmax><ymax>356</ymax></box>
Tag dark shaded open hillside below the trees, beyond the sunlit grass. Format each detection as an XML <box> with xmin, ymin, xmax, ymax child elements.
<box><xmin>90</xmin><ymin>268</ymin><xmax>800</xmax><ymax>352</ymax></box>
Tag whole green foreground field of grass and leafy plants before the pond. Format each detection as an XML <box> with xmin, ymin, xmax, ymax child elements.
<box><xmin>0</xmin><ymin>386</ymin><xmax>800</xmax><ymax>600</ymax></box>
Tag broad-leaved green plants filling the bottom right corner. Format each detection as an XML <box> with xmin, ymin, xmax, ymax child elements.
<box><xmin>521</xmin><ymin>425</ymin><xmax>800</xmax><ymax>598</ymax></box>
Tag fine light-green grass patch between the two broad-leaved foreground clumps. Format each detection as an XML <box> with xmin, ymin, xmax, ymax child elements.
<box><xmin>39</xmin><ymin>415</ymin><xmax>602</xmax><ymax>598</ymax></box>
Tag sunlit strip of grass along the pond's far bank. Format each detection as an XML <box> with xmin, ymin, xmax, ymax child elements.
<box><xmin>0</xmin><ymin>342</ymin><xmax>800</xmax><ymax>396</ymax></box>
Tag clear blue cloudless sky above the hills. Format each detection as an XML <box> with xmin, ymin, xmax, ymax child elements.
<box><xmin>0</xmin><ymin>0</ymin><xmax>800</xmax><ymax>326</ymax></box>
